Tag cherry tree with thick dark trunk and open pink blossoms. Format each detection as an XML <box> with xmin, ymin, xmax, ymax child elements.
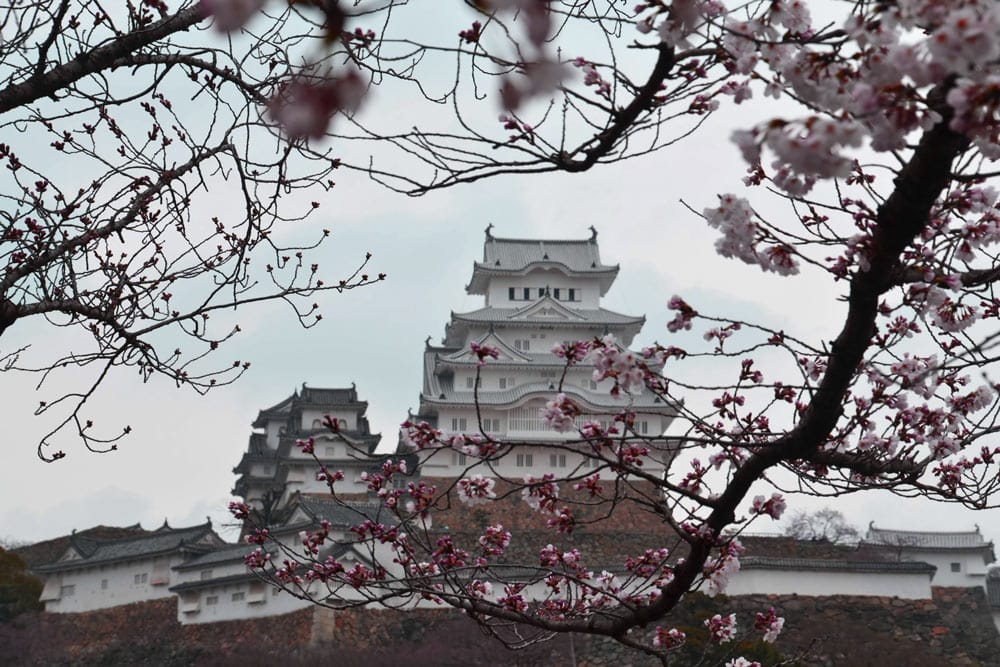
<box><xmin>219</xmin><ymin>0</ymin><xmax>1000</xmax><ymax>665</ymax></box>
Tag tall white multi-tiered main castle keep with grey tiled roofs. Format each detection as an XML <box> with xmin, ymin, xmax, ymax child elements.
<box><xmin>414</xmin><ymin>225</ymin><xmax>674</xmax><ymax>478</ymax></box>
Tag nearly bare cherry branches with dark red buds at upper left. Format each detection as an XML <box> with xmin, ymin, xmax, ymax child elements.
<box><xmin>0</xmin><ymin>0</ymin><xmax>381</xmax><ymax>460</ymax></box>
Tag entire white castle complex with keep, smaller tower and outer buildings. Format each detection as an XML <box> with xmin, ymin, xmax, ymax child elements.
<box><xmin>14</xmin><ymin>228</ymin><xmax>1000</xmax><ymax>626</ymax></box>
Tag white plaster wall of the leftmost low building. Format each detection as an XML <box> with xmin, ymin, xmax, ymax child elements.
<box><xmin>45</xmin><ymin>557</ymin><xmax>180</xmax><ymax>613</ymax></box>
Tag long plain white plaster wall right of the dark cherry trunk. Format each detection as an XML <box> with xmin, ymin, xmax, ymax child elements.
<box><xmin>725</xmin><ymin>569</ymin><xmax>931</xmax><ymax>600</ymax></box>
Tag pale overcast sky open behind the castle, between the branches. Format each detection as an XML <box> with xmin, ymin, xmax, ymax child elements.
<box><xmin>0</xmin><ymin>2</ymin><xmax>1000</xmax><ymax>552</ymax></box>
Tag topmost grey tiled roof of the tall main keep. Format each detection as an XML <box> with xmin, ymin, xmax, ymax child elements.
<box><xmin>466</xmin><ymin>225</ymin><xmax>618</xmax><ymax>295</ymax></box>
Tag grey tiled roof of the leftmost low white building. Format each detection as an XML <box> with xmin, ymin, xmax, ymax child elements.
<box><xmin>36</xmin><ymin>521</ymin><xmax>225</xmax><ymax>572</ymax></box>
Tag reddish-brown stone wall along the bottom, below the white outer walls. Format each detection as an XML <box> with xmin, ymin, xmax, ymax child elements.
<box><xmin>0</xmin><ymin>588</ymin><xmax>1000</xmax><ymax>667</ymax></box>
